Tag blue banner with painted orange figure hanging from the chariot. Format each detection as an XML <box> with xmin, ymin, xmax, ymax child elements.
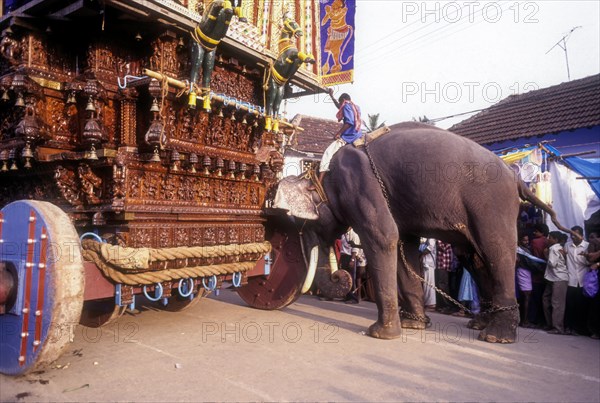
<box><xmin>319</xmin><ymin>0</ymin><xmax>356</xmax><ymax>86</ymax></box>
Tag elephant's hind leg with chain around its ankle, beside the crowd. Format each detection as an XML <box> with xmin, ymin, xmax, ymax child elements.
<box><xmin>468</xmin><ymin>229</ymin><xmax>519</xmax><ymax>343</ymax></box>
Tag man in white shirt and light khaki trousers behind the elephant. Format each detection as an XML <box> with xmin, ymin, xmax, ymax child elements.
<box><xmin>543</xmin><ymin>231</ymin><xmax>569</xmax><ymax>334</ymax></box>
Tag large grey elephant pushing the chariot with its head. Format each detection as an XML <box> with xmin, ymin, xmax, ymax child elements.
<box><xmin>274</xmin><ymin>122</ymin><xmax>564</xmax><ymax>343</ymax></box>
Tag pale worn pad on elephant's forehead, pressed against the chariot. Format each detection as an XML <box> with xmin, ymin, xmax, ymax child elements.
<box><xmin>273</xmin><ymin>176</ymin><xmax>319</xmax><ymax>220</ymax></box>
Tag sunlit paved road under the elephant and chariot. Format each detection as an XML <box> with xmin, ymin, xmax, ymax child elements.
<box><xmin>0</xmin><ymin>291</ymin><xmax>600</xmax><ymax>402</ymax></box>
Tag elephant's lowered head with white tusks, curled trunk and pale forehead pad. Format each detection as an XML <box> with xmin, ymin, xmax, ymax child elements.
<box><xmin>273</xmin><ymin>176</ymin><xmax>352</xmax><ymax>298</ymax></box>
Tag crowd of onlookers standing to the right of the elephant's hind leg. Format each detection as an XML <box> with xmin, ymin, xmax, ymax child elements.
<box><xmin>516</xmin><ymin>223</ymin><xmax>600</xmax><ymax>339</ymax></box>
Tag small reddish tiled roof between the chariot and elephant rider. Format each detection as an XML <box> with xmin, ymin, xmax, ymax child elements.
<box><xmin>292</xmin><ymin>115</ymin><xmax>341</xmax><ymax>154</ymax></box>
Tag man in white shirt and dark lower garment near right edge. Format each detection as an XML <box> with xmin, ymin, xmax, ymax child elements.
<box><xmin>565</xmin><ymin>225</ymin><xmax>589</xmax><ymax>334</ymax></box>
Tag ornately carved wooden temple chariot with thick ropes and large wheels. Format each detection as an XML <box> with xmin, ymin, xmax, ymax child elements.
<box><xmin>0</xmin><ymin>0</ymin><xmax>322</xmax><ymax>374</ymax></box>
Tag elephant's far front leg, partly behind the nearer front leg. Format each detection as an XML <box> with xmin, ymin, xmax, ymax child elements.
<box><xmin>397</xmin><ymin>239</ymin><xmax>429</xmax><ymax>329</ymax></box>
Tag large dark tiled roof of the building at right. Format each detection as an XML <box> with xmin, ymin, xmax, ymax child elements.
<box><xmin>449</xmin><ymin>74</ymin><xmax>600</xmax><ymax>144</ymax></box>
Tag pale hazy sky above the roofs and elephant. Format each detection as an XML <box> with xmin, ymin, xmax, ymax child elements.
<box><xmin>282</xmin><ymin>0</ymin><xmax>600</xmax><ymax>128</ymax></box>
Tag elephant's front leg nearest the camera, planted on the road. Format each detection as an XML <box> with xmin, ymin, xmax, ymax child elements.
<box><xmin>360</xmin><ymin>220</ymin><xmax>401</xmax><ymax>339</ymax></box>
